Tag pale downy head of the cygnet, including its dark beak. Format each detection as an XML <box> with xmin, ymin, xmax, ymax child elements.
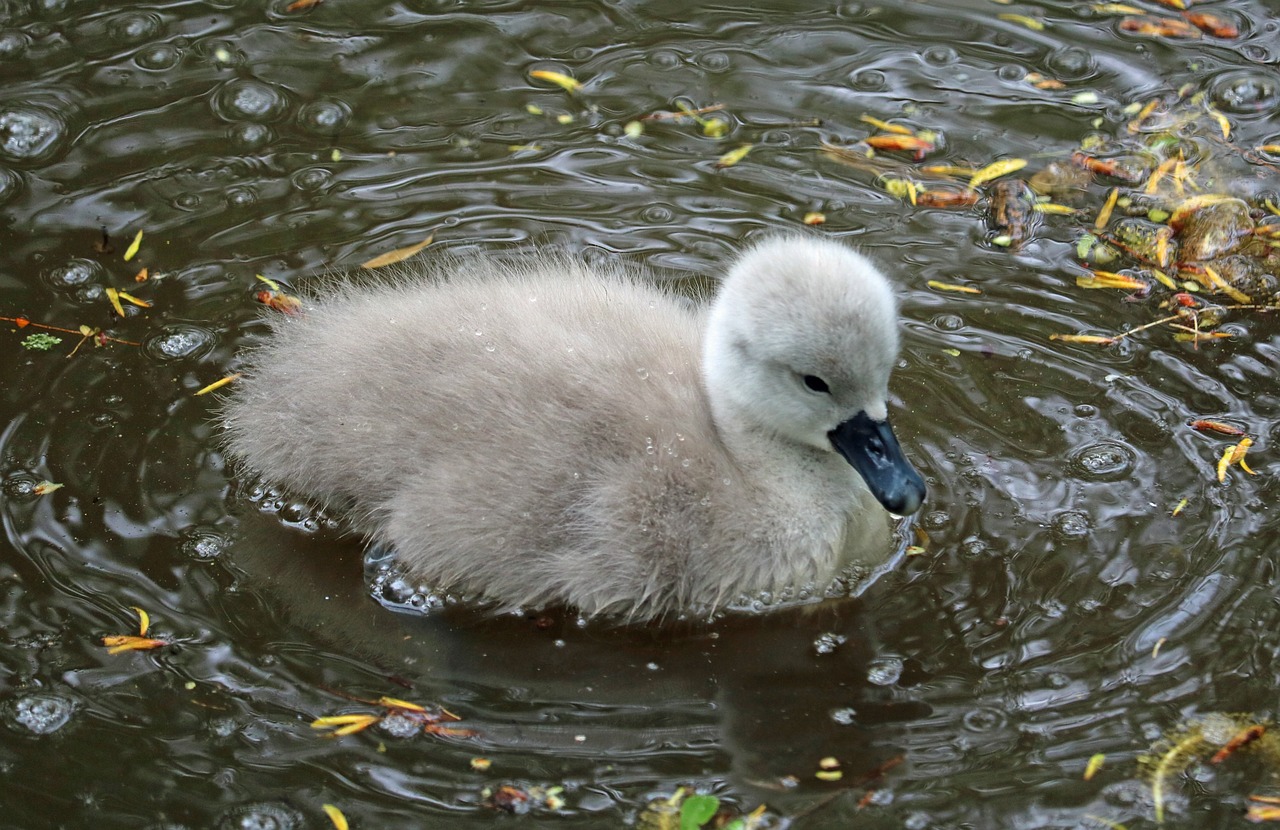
<box><xmin>703</xmin><ymin>237</ymin><xmax>924</xmax><ymax>515</ymax></box>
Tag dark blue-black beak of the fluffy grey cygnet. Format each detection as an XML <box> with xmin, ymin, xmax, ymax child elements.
<box><xmin>827</xmin><ymin>412</ymin><xmax>924</xmax><ymax>516</ymax></box>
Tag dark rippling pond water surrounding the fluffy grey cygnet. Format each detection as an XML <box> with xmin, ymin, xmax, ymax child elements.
<box><xmin>0</xmin><ymin>0</ymin><xmax>1280</xmax><ymax>829</ymax></box>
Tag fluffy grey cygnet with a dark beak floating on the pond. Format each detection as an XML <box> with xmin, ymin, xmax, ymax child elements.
<box><xmin>225</xmin><ymin>237</ymin><xmax>924</xmax><ymax>620</ymax></box>
